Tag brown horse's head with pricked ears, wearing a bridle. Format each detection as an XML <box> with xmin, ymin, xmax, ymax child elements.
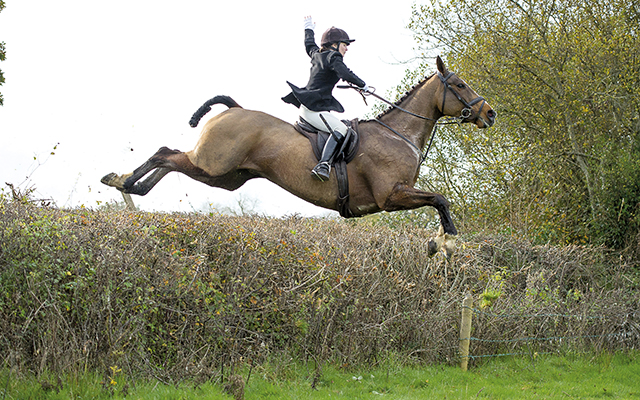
<box><xmin>436</xmin><ymin>56</ymin><xmax>497</xmax><ymax>128</ymax></box>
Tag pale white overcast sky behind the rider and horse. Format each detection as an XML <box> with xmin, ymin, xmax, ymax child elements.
<box><xmin>0</xmin><ymin>0</ymin><xmax>428</xmax><ymax>217</ymax></box>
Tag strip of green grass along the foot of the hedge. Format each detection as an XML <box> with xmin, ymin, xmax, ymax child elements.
<box><xmin>5</xmin><ymin>352</ymin><xmax>640</xmax><ymax>400</ymax></box>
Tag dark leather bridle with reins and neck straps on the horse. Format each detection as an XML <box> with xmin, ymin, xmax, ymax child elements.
<box><xmin>337</xmin><ymin>71</ymin><xmax>486</xmax><ymax>169</ymax></box>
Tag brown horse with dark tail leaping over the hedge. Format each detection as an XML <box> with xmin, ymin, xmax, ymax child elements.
<box><xmin>101</xmin><ymin>56</ymin><xmax>497</xmax><ymax>258</ymax></box>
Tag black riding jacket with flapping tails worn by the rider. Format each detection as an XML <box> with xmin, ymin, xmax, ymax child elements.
<box><xmin>282</xmin><ymin>29</ymin><xmax>365</xmax><ymax>112</ymax></box>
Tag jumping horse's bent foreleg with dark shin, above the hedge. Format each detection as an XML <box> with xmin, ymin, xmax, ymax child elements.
<box><xmin>384</xmin><ymin>183</ymin><xmax>458</xmax><ymax>258</ymax></box>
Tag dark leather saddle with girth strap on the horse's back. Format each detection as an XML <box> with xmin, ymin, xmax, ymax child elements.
<box><xmin>294</xmin><ymin>118</ymin><xmax>360</xmax><ymax>218</ymax></box>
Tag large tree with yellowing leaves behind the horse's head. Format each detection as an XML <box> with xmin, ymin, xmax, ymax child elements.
<box><xmin>410</xmin><ymin>0</ymin><xmax>640</xmax><ymax>247</ymax></box>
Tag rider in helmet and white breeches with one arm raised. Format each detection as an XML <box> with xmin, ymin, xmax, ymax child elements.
<box><xmin>282</xmin><ymin>17</ymin><xmax>369</xmax><ymax>181</ymax></box>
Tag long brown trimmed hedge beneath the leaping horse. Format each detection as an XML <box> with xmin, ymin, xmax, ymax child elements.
<box><xmin>0</xmin><ymin>199</ymin><xmax>640</xmax><ymax>382</ymax></box>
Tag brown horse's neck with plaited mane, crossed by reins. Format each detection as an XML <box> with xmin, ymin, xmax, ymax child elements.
<box><xmin>380</xmin><ymin>82</ymin><xmax>440</xmax><ymax>149</ymax></box>
